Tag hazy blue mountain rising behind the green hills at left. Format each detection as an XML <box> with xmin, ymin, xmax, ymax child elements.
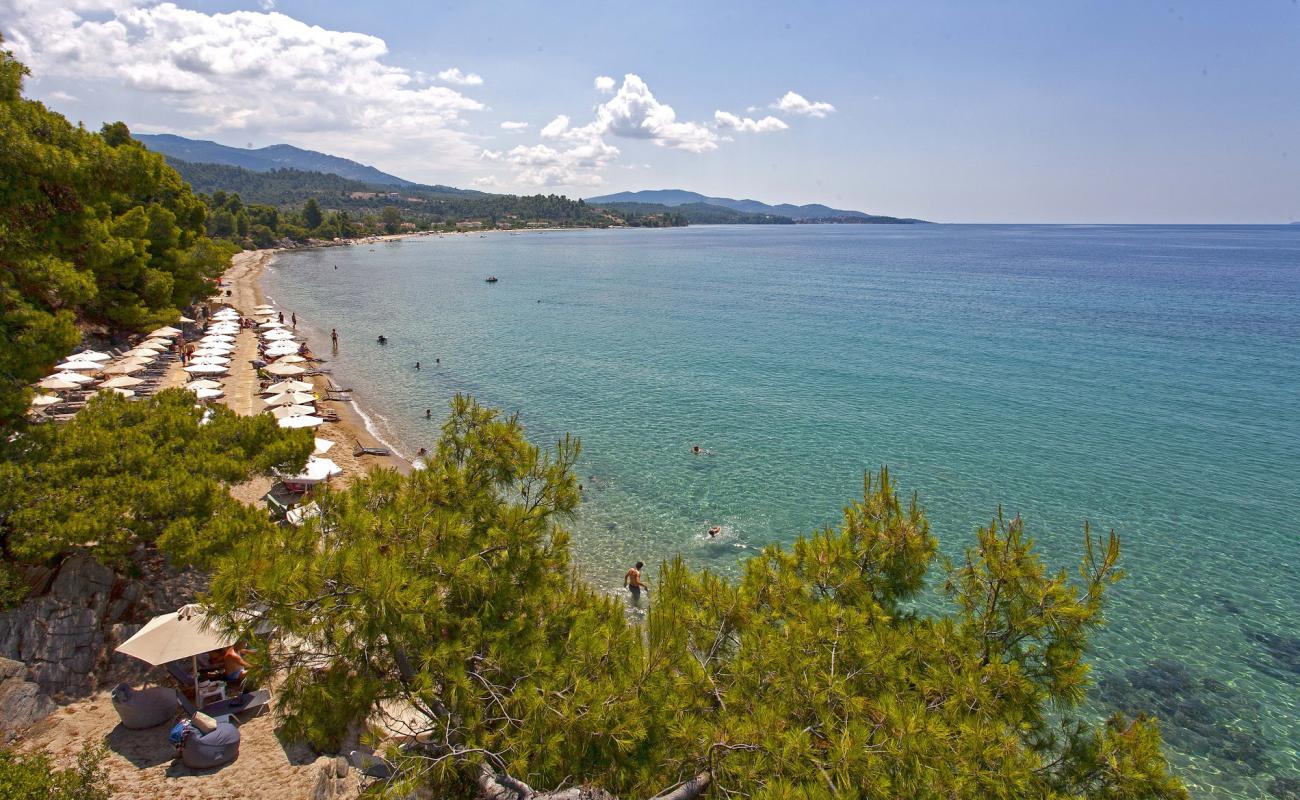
<box><xmin>134</xmin><ymin>134</ymin><xmax>419</xmax><ymax>187</ymax></box>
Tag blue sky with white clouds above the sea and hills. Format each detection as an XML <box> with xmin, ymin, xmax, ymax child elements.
<box><xmin>0</xmin><ymin>0</ymin><xmax>1300</xmax><ymax>222</ymax></box>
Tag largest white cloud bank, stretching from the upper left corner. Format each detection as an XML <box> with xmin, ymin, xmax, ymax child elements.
<box><xmin>0</xmin><ymin>0</ymin><xmax>484</xmax><ymax>175</ymax></box>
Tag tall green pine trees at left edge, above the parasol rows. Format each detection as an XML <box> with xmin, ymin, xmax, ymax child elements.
<box><xmin>0</xmin><ymin>42</ymin><xmax>237</xmax><ymax>427</ymax></box>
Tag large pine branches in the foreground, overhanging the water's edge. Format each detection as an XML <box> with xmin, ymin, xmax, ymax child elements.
<box><xmin>212</xmin><ymin>398</ymin><xmax>1186</xmax><ymax>800</ymax></box>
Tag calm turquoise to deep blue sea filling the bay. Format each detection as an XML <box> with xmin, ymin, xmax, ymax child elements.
<box><xmin>258</xmin><ymin>225</ymin><xmax>1300</xmax><ymax>797</ymax></box>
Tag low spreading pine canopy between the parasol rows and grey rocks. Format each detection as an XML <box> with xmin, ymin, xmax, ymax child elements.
<box><xmin>0</xmin><ymin>389</ymin><xmax>312</xmax><ymax>566</ymax></box>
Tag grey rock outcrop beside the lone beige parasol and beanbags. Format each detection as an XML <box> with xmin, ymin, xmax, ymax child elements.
<box><xmin>0</xmin><ymin>550</ymin><xmax>204</xmax><ymax>701</ymax></box>
